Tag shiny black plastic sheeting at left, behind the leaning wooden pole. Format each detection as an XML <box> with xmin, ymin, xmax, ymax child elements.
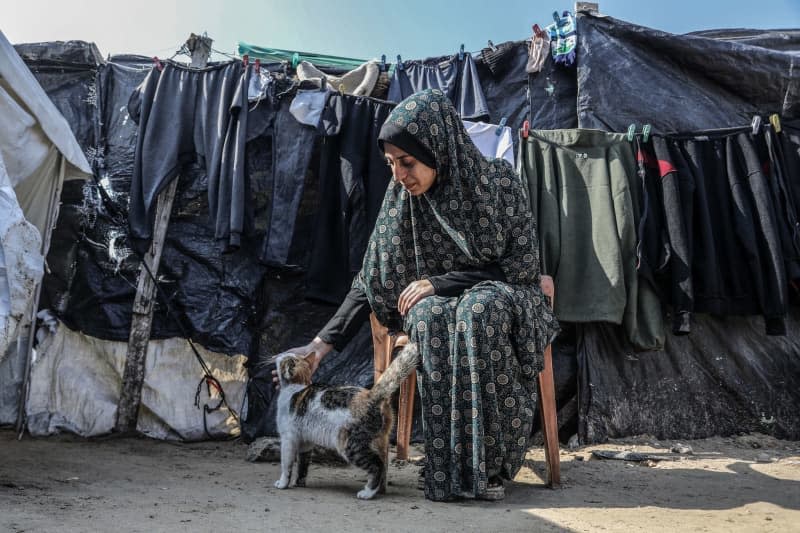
<box><xmin>29</xmin><ymin>50</ymin><xmax>269</xmax><ymax>355</ymax></box>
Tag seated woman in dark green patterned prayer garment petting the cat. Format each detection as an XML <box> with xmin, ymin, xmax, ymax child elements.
<box><xmin>278</xmin><ymin>90</ymin><xmax>558</xmax><ymax>501</ymax></box>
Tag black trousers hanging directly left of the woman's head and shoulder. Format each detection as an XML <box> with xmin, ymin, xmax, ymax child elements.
<box><xmin>306</xmin><ymin>93</ymin><xmax>394</xmax><ymax>304</ymax></box>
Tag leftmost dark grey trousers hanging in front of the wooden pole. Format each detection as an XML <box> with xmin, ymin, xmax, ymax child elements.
<box><xmin>128</xmin><ymin>61</ymin><xmax>249</xmax><ymax>251</ymax></box>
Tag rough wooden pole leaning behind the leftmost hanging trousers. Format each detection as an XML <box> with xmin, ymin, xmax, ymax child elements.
<box><xmin>114</xmin><ymin>33</ymin><xmax>213</xmax><ymax>434</ymax></box>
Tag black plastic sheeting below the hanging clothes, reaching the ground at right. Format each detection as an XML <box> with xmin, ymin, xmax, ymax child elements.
<box><xmin>577</xmin><ymin>309</ymin><xmax>800</xmax><ymax>443</ymax></box>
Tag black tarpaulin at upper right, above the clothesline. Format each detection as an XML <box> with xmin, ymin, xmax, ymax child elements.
<box><xmin>577</xmin><ymin>15</ymin><xmax>800</xmax><ymax>133</ymax></box>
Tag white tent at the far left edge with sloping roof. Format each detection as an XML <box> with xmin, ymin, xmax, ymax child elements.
<box><xmin>0</xmin><ymin>33</ymin><xmax>92</xmax><ymax>424</ymax></box>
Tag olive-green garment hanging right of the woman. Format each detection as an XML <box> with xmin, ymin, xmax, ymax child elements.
<box><xmin>520</xmin><ymin>130</ymin><xmax>664</xmax><ymax>350</ymax></box>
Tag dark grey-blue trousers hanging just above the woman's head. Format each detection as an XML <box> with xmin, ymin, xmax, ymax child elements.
<box><xmin>389</xmin><ymin>53</ymin><xmax>489</xmax><ymax>120</ymax></box>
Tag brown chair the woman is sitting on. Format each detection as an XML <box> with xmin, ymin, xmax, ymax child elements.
<box><xmin>369</xmin><ymin>276</ymin><xmax>561</xmax><ymax>488</ymax></box>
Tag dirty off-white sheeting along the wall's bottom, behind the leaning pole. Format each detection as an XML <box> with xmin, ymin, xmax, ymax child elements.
<box><xmin>26</xmin><ymin>318</ymin><xmax>247</xmax><ymax>441</ymax></box>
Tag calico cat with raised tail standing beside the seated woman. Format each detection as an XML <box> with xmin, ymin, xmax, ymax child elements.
<box><xmin>274</xmin><ymin>343</ymin><xmax>419</xmax><ymax>500</ymax></box>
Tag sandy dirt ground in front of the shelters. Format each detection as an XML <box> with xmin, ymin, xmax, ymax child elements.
<box><xmin>0</xmin><ymin>430</ymin><xmax>800</xmax><ymax>532</ymax></box>
